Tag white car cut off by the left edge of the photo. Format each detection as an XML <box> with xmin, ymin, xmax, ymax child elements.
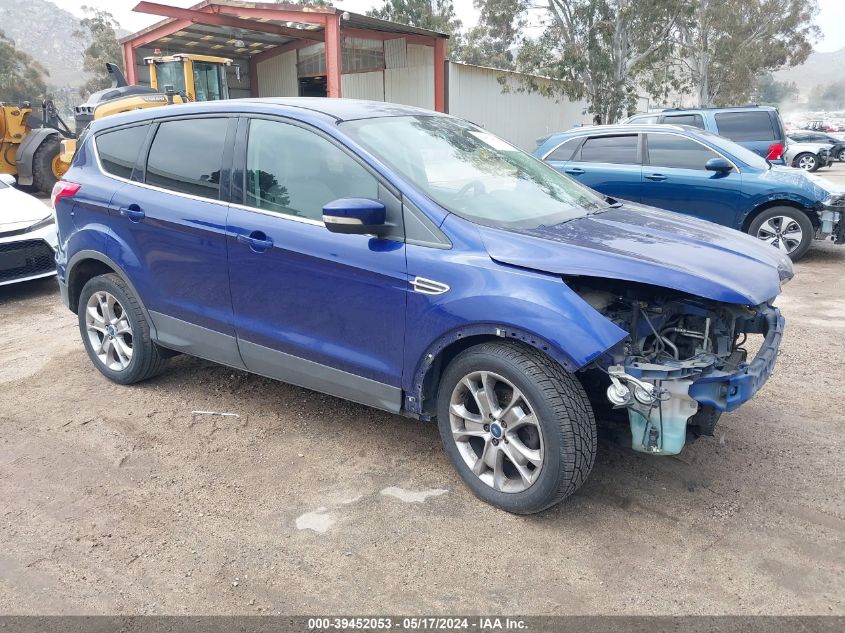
<box><xmin>0</xmin><ymin>174</ymin><xmax>58</xmax><ymax>286</ymax></box>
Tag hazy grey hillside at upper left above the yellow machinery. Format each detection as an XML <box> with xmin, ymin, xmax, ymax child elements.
<box><xmin>0</xmin><ymin>0</ymin><xmax>86</xmax><ymax>88</ymax></box>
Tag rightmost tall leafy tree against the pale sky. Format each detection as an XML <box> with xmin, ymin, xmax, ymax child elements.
<box><xmin>667</xmin><ymin>0</ymin><xmax>818</xmax><ymax>106</ymax></box>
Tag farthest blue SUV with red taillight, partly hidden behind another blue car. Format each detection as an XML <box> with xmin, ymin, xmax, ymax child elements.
<box><xmin>623</xmin><ymin>105</ymin><xmax>787</xmax><ymax>165</ymax></box>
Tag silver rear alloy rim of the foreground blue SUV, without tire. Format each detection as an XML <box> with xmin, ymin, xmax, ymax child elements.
<box><xmin>85</xmin><ymin>290</ymin><xmax>132</xmax><ymax>371</ymax></box>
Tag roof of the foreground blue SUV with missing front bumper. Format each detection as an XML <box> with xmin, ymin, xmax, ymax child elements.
<box><xmin>92</xmin><ymin>97</ymin><xmax>448</xmax><ymax>131</ymax></box>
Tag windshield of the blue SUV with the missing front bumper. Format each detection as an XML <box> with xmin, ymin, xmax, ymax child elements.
<box><xmin>343</xmin><ymin>116</ymin><xmax>609</xmax><ymax>228</ymax></box>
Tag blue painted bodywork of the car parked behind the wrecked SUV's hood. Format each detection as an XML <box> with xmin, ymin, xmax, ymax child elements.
<box><xmin>534</xmin><ymin>124</ymin><xmax>838</xmax><ymax>230</ymax></box>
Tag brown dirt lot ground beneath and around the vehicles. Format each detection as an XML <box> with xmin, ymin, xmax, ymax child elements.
<box><xmin>0</xmin><ymin>170</ymin><xmax>845</xmax><ymax>614</ymax></box>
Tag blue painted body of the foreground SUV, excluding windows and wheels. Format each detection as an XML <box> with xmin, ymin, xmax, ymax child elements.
<box><xmin>58</xmin><ymin>99</ymin><xmax>792</xmax><ymax>424</ymax></box>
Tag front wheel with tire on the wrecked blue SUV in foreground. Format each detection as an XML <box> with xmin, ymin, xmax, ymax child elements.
<box><xmin>437</xmin><ymin>342</ymin><xmax>596</xmax><ymax>514</ymax></box>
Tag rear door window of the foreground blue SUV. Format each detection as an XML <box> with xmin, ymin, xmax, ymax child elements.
<box><xmin>145</xmin><ymin>118</ymin><xmax>229</xmax><ymax>200</ymax></box>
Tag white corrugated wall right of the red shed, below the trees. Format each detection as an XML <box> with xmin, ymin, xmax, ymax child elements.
<box><xmin>448</xmin><ymin>63</ymin><xmax>591</xmax><ymax>151</ymax></box>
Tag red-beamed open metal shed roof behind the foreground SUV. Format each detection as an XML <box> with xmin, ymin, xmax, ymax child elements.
<box><xmin>119</xmin><ymin>0</ymin><xmax>449</xmax><ymax>57</ymax></box>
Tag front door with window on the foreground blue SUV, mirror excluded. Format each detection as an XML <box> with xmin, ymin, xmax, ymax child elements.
<box><xmin>227</xmin><ymin>118</ymin><xmax>408</xmax><ymax>411</ymax></box>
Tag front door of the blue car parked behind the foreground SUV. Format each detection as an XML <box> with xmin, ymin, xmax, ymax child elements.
<box><xmin>642</xmin><ymin>132</ymin><xmax>742</xmax><ymax>226</ymax></box>
